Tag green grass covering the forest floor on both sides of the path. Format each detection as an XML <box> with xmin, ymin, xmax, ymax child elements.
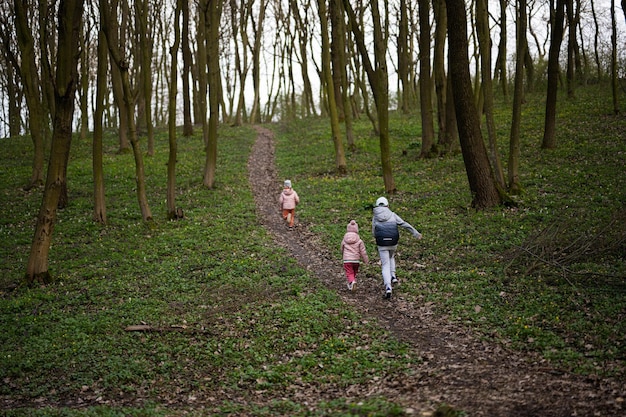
<box><xmin>0</xmin><ymin>83</ymin><xmax>626</xmax><ymax>416</ymax></box>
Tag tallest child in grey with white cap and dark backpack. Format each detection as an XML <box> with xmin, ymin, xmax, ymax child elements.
<box><xmin>372</xmin><ymin>197</ymin><xmax>422</xmax><ymax>298</ymax></box>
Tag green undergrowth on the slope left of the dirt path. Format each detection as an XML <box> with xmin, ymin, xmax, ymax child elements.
<box><xmin>0</xmin><ymin>127</ymin><xmax>418</xmax><ymax>416</ymax></box>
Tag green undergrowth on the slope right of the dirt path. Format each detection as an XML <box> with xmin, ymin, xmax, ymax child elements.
<box><xmin>277</xmin><ymin>83</ymin><xmax>626</xmax><ymax>376</ymax></box>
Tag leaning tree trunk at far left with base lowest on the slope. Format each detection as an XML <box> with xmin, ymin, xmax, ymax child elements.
<box><xmin>26</xmin><ymin>0</ymin><xmax>83</xmax><ymax>284</ymax></box>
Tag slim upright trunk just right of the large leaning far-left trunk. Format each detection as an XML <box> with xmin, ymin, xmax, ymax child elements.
<box><xmin>92</xmin><ymin>30</ymin><xmax>109</xmax><ymax>224</ymax></box>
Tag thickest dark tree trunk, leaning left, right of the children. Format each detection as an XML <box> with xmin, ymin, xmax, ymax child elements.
<box><xmin>446</xmin><ymin>0</ymin><xmax>501</xmax><ymax>209</ymax></box>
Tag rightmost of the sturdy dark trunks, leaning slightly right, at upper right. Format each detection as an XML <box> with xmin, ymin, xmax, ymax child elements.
<box><xmin>541</xmin><ymin>0</ymin><xmax>565</xmax><ymax>149</ymax></box>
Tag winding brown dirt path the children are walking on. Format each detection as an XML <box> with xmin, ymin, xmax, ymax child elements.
<box><xmin>248</xmin><ymin>127</ymin><xmax>626</xmax><ymax>417</ymax></box>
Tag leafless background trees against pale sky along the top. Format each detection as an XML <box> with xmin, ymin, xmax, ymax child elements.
<box><xmin>0</xmin><ymin>0</ymin><xmax>626</xmax><ymax>137</ymax></box>
